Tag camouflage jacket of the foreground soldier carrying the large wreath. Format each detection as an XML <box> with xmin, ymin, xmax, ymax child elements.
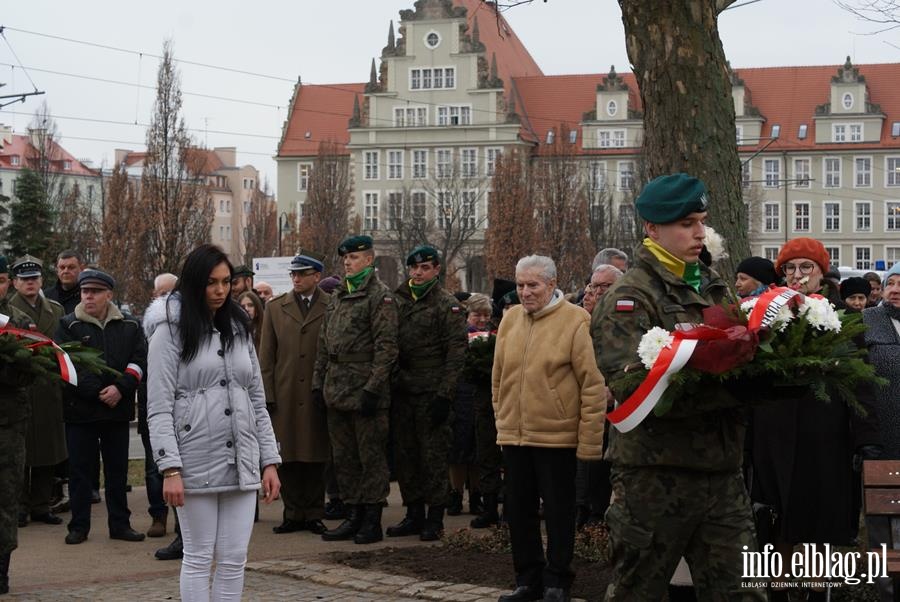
<box><xmin>591</xmin><ymin>241</ymin><xmax>747</xmax><ymax>472</ymax></box>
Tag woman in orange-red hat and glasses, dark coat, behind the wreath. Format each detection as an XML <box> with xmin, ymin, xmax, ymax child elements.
<box><xmin>751</xmin><ymin>238</ymin><xmax>880</xmax><ymax>601</ymax></box>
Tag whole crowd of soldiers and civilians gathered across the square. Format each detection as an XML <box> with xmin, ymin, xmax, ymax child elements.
<box><xmin>0</xmin><ymin>174</ymin><xmax>900</xmax><ymax>602</ymax></box>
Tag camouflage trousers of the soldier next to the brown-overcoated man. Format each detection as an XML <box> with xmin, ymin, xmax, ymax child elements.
<box><xmin>328</xmin><ymin>408</ymin><xmax>390</xmax><ymax>504</ymax></box>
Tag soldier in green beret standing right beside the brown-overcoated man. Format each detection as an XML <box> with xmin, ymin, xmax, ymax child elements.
<box><xmin>312</xmin><ymin>236</ymin><xmax>397</xmax><ymax>544</ymax></box>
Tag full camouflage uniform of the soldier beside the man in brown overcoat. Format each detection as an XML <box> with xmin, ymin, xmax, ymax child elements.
<box><xmin>312</xmin><ymin>272</ymin><xmax>397</xmax><ymax>504</ymax></box>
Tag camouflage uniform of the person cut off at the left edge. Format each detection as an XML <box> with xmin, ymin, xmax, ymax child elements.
<box><xmin>0</xmin><ymin>298</ymin><xmax>31</xmax><ymax>557</ymax></box>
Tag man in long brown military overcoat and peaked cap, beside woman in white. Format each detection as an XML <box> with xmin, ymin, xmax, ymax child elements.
<box><xmin>259</xmin><ymin>250</ymin><xmax>331</xmax><ymax>535</ymax></box>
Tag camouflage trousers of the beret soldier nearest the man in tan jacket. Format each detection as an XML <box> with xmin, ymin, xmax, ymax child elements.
<box><xmin>391</xmin><ymin>393</ymin><xmax>453</xmax><ymax>506</ymax></box>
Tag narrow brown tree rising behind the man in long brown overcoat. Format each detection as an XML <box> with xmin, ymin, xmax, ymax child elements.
<box><xmin>300</xmin><ymin>142</ymin><xmax>353</xmax><ymax>273</ymax></box>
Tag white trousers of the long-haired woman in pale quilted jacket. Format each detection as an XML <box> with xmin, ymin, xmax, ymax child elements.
<box><xmin>178</xmin><ymin>491</ymin><xmax>257</xmax><ymax>602</ymax></box>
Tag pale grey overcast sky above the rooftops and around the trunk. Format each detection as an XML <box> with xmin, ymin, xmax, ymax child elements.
<box><xmin>0</xmin><ymin>0</ymin><xmax>900</xmax><ymax>184</ymax></box>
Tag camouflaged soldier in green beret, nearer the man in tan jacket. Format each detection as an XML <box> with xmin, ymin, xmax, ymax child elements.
<box><xmin>387</xmin><ymin>245</ymin><xmax>467</xmax><ymax>541</ymax></box>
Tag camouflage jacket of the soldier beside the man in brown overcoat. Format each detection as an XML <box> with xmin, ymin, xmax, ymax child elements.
<box><xmin>312</xmin><ymin>272</ymin><xmax>397</xmax><ymax>410</ymax></box>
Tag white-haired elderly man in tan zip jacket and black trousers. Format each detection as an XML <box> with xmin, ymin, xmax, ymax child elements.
<box><xmin>492</xmin><ymin>255</ymin><xmax>606</xmax><ymax>602</ymax></box>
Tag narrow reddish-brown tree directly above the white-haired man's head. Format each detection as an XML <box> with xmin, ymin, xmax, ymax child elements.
<box><xmin>484</xmin><ymin>149</ymin><xmax>537</xmax><ymax>280</ymax></box>
